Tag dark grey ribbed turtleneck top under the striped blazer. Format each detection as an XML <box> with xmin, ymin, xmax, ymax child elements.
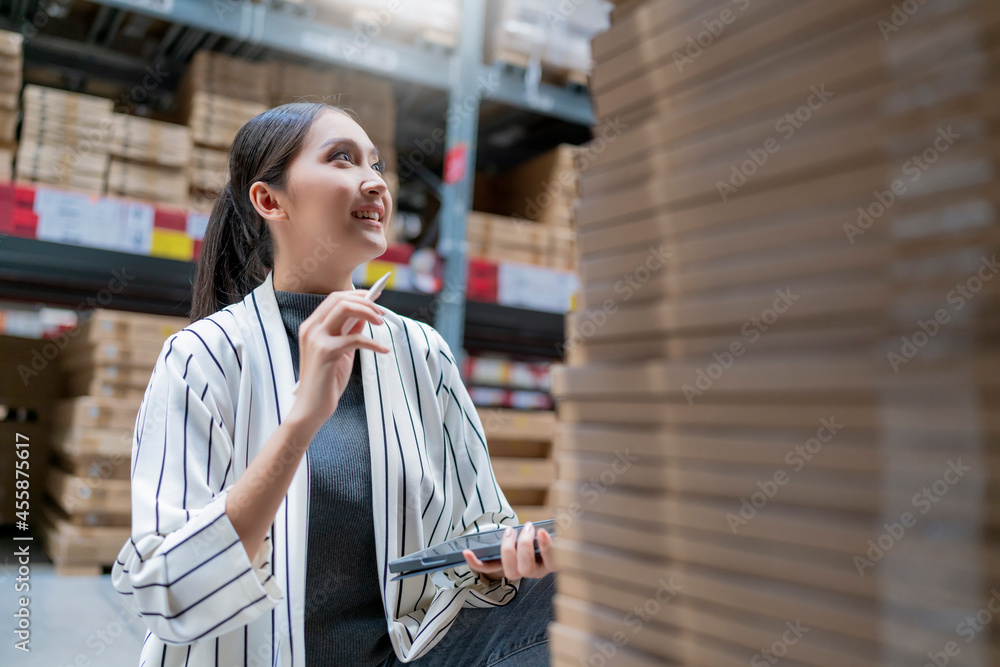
<box><xmin>274</xmin><ymin>290</ymin><xmax>392</xmax><ymax>667</ymax></box>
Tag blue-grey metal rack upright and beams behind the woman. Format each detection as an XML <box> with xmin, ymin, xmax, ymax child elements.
<box><xmin>0</xmin><ymin>0</ymin><xmax>593</xmax><ymax>357</ymax></box>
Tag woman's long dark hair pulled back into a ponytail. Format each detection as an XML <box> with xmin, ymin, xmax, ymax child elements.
<box><xmin>191</xmin><ymin>102</ymin><xmax>354</xmax><ymax>322</ymax></box>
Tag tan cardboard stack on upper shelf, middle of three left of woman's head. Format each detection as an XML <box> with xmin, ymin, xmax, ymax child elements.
<box><xmin>107</xmin><ymin>113</ymin><xmax>191</xmax><ymax>205</ymax></box>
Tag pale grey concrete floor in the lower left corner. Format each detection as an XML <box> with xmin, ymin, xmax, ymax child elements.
<box><xmin>0</xmin><ymin>531</ymin><xmax>146</xmax><ymax>667</ymax></box>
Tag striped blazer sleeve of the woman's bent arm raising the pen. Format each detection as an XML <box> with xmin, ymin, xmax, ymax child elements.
<box><xmin>111</xmin><ymin>328</ymin><xmax>284</xmax><ymax>644</ymax></box>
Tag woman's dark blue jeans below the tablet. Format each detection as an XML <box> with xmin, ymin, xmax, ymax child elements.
<box><xmin>382</xmin><ymin>574</ymin><xmax>556</xmax><ymax>667</ymax></box>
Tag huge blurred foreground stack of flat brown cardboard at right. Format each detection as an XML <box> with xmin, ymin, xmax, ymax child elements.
<box><xmin>550</xmin><ymin>0</ymin><xmax>1000</xmax><ymax>667</ymax></box>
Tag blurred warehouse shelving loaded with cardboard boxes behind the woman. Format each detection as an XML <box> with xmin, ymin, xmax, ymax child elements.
<box><xmin>0</xmin><ymin>0</ymin><xmax>610</xmax><ymax>574</ymax></box>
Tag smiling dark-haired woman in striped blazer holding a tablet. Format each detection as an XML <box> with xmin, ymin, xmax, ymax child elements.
<box><xmin>112</xmin><ymin>104</ymin><xmax>553</xmax><ymax>667</ymax></box>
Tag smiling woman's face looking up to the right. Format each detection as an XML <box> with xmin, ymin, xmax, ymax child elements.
<box><xmin>251</xmin><ymin>110</ymin><xmax>392</xmax><ymax>292</ymax></box>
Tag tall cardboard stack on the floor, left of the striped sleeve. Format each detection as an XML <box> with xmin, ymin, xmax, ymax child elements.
<box><xmin>45</xmin><ymin>309</ymin><xmax>188</xmax><ymax>574</ymax></box>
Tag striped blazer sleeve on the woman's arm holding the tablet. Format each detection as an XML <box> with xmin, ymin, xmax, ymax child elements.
<box><xmin>437</xmin><ymin>335</ymin><xmax>520</xmax><ymax>607</ymax></box>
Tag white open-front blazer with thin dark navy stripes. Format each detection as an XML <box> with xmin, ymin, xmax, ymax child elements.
<box><xmin>111</xmin><ymin>274</ymin><xmax>520</xmax><ymax>667</ymax></box>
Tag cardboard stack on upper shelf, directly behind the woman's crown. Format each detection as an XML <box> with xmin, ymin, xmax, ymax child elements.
<box><xmin>178</xmin><ymin>51</ymin><xmax>271</xmax><ymax>209</ymax></box>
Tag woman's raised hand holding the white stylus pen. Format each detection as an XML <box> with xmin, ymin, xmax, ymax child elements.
<box><xmin>289</xmin><ymin>289</ymin><xmax>390</xmax><ymax>430</ymax></box>
